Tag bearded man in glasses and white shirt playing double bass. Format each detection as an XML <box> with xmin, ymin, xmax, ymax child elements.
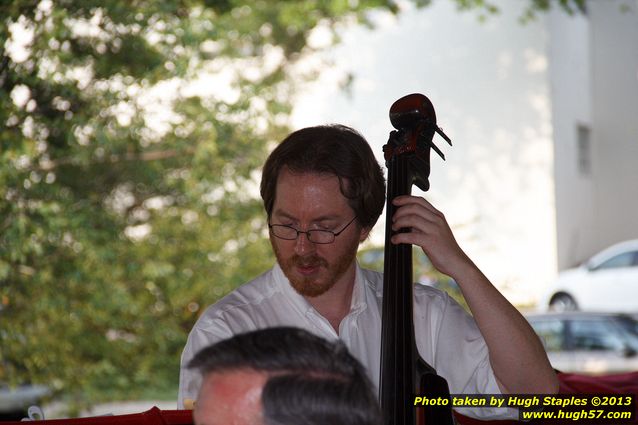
<box><xmin>178</xmin><ymin>125</ymin><xmax>558</xmax><ymax>418</ymax></box>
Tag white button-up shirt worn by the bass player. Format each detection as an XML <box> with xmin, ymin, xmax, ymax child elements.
<box><xmin>178</xmin><ymin>265</ymin><xmax>511</xmax><ymax>418</ymax></box>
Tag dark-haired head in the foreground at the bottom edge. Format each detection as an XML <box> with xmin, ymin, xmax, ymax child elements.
<box><xmin>189</xmin><ymin>327</ymin><xmax>381</xmax><ymax>425</ymax></box>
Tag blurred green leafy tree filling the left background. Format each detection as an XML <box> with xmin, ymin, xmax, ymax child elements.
<box><xmin>0</xmin><ymin>0</ymin><xmax>579</xmax><ymax>405</ymax></box>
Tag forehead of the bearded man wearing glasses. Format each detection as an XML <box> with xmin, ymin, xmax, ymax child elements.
<box><xmin>273</xmin><ymin>168</ymin><xmax>352</xmax><ymax>218</ymax></box>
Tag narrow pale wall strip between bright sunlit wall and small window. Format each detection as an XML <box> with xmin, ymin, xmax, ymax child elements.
<box><xmin>548</xmin><ymin>4</ymin><xmax>595</xmax><ymax>269</ymax></box>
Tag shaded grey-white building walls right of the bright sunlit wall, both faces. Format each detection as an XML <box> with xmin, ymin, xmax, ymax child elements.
<box><xmin>548</xmin><ymin>0</ymin><xmax>638</xmax><ymax>269</ymax></box>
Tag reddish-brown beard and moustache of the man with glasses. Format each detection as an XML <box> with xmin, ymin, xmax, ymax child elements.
<box><xmin>271</xmin><ymin>238</ymin><xmax>359</xmax><ymax>298</ymax></box>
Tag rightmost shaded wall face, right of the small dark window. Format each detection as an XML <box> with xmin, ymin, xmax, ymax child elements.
<box><xmin>588</xmin><ymin>0</ymin><xmax>638</xmax><ymax>249</ymax></box>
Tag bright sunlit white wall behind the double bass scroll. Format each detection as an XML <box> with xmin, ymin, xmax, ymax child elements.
<box><xmin>292</xmin><ymin>1</ymin><xmax>556</xmax><ymax>304</ymax></box>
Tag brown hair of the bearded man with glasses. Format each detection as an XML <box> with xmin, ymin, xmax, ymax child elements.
<box><xmin>261</xmin><ymin>125</ymin><xmax>385</xmax><ymax>229</ymax></box>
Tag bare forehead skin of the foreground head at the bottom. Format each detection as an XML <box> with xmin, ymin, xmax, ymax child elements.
<box><xmin>193</xmin><ymin>369</ymin><xmax>267</xmax><ymax>425</ymax></box>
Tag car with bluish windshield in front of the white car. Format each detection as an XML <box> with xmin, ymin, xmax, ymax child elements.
<box><xmin>526</xmin><ymin>312</ymin><xmax>638</xmax><ymax>374</ymax></box>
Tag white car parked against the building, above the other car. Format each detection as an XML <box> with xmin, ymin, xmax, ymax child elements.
<box><xmin>540</xmin><ymin>239</ymin><xmax>638</xmax><ymax>313</ymax></box>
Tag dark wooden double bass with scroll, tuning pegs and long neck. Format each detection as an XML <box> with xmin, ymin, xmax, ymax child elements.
<box><xmin>379</xmin><ymin>93</ymin><xmax>454</xmax><ymax>425</ymax></box>
